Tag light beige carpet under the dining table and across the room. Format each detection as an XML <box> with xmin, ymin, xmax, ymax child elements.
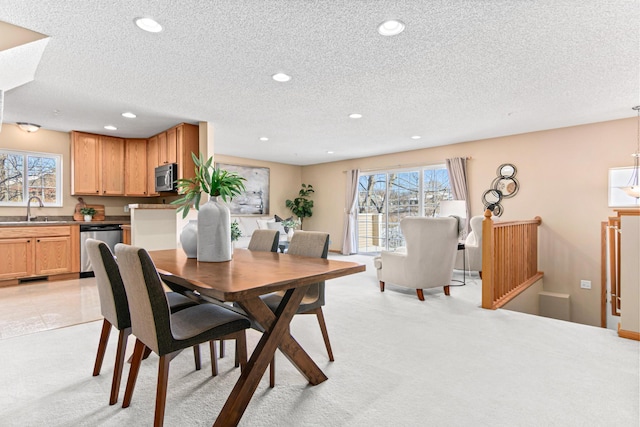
<box><xmin>0</xmin><ymin>257</ymin><xmax>640</xmax><ymax>427</ymax></box>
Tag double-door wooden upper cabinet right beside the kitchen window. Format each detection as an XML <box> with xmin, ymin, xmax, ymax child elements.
<box><xmin>71</xmin><ymin>131</ymin><xmax>124</xmax><ymax>196</ymax></box>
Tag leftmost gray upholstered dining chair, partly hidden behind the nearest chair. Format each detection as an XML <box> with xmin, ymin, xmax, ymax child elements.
<box><xmin>86</xmin><ymin>239</ymin><xmax>200</xmax><ymax>405</ymax></box>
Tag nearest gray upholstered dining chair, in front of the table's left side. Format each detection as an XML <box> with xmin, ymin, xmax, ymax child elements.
<box><xmin>115</xmin><ymin>243</ymin><xmax>251</xmax><ymax>426</ymax></box>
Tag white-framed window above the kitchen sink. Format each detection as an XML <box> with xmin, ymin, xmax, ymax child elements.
<box><xmin>0</xmin><ymin>150</ymin><xmax>62</xmax><ymax>206</ymax></box>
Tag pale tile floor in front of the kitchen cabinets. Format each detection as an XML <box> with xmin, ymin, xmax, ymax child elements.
<box><xmin>0</xmin><ymin>277</ymin><xmax>102</xmax><ymax>339</ymax></box>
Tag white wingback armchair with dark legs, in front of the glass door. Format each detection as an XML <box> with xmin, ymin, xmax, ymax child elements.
<box><xmin>374</xmin><ymin>217</ymin><xmax>458</xmax><ymax>301</ymax></box>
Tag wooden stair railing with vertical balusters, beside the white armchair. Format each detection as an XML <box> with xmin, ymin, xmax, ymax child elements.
<box><xmin>482</xmin><ymin>209</ymin><xmax>543</xmax><ymax>310</ymax></box>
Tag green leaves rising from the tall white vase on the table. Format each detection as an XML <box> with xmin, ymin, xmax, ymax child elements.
<box><xmin>171</xmin><ymin>153</ymin><xmax>246</xmax><ymax>218</ymax></box>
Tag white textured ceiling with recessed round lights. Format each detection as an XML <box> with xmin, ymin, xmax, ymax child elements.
<box><xmin>0</xmin><ymin>0</ymin><xmax>640</xmax><ymax>165</ymax></box>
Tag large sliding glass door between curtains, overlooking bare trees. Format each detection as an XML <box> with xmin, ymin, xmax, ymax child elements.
<box><xmin>358</xmin><ymin>166</ymin><xmax>451</xmax><ymax>252</ymax></box>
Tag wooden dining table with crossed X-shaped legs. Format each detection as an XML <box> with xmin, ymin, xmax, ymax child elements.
<box><xmin>149</xmin><ymin>249</ymin><xmax>365</xmax><ymax>426</ymax></box>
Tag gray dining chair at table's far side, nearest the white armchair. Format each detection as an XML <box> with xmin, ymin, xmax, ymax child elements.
<box><xmin>261</xmin><ymin>231</ymin><xmax>334</xmax><ymax>387</ymax></box>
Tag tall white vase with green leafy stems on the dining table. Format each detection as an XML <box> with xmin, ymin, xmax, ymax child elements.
<box><xmin>171</xmin><ymin>153</ymin><xmax>246</xmax><ymax>262</ymax></box>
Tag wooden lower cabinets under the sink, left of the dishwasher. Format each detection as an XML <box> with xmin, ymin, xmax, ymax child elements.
<box><xmin>0</xmin><ymin>225</ymin><xmax>80</xmax><ymax>286</ymax></box>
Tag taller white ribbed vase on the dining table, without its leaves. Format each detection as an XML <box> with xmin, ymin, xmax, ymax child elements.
<box><xmin>197</xmin><ymin>197</ymin><xmax>233</xmax><ymax>262</ymax></box>
